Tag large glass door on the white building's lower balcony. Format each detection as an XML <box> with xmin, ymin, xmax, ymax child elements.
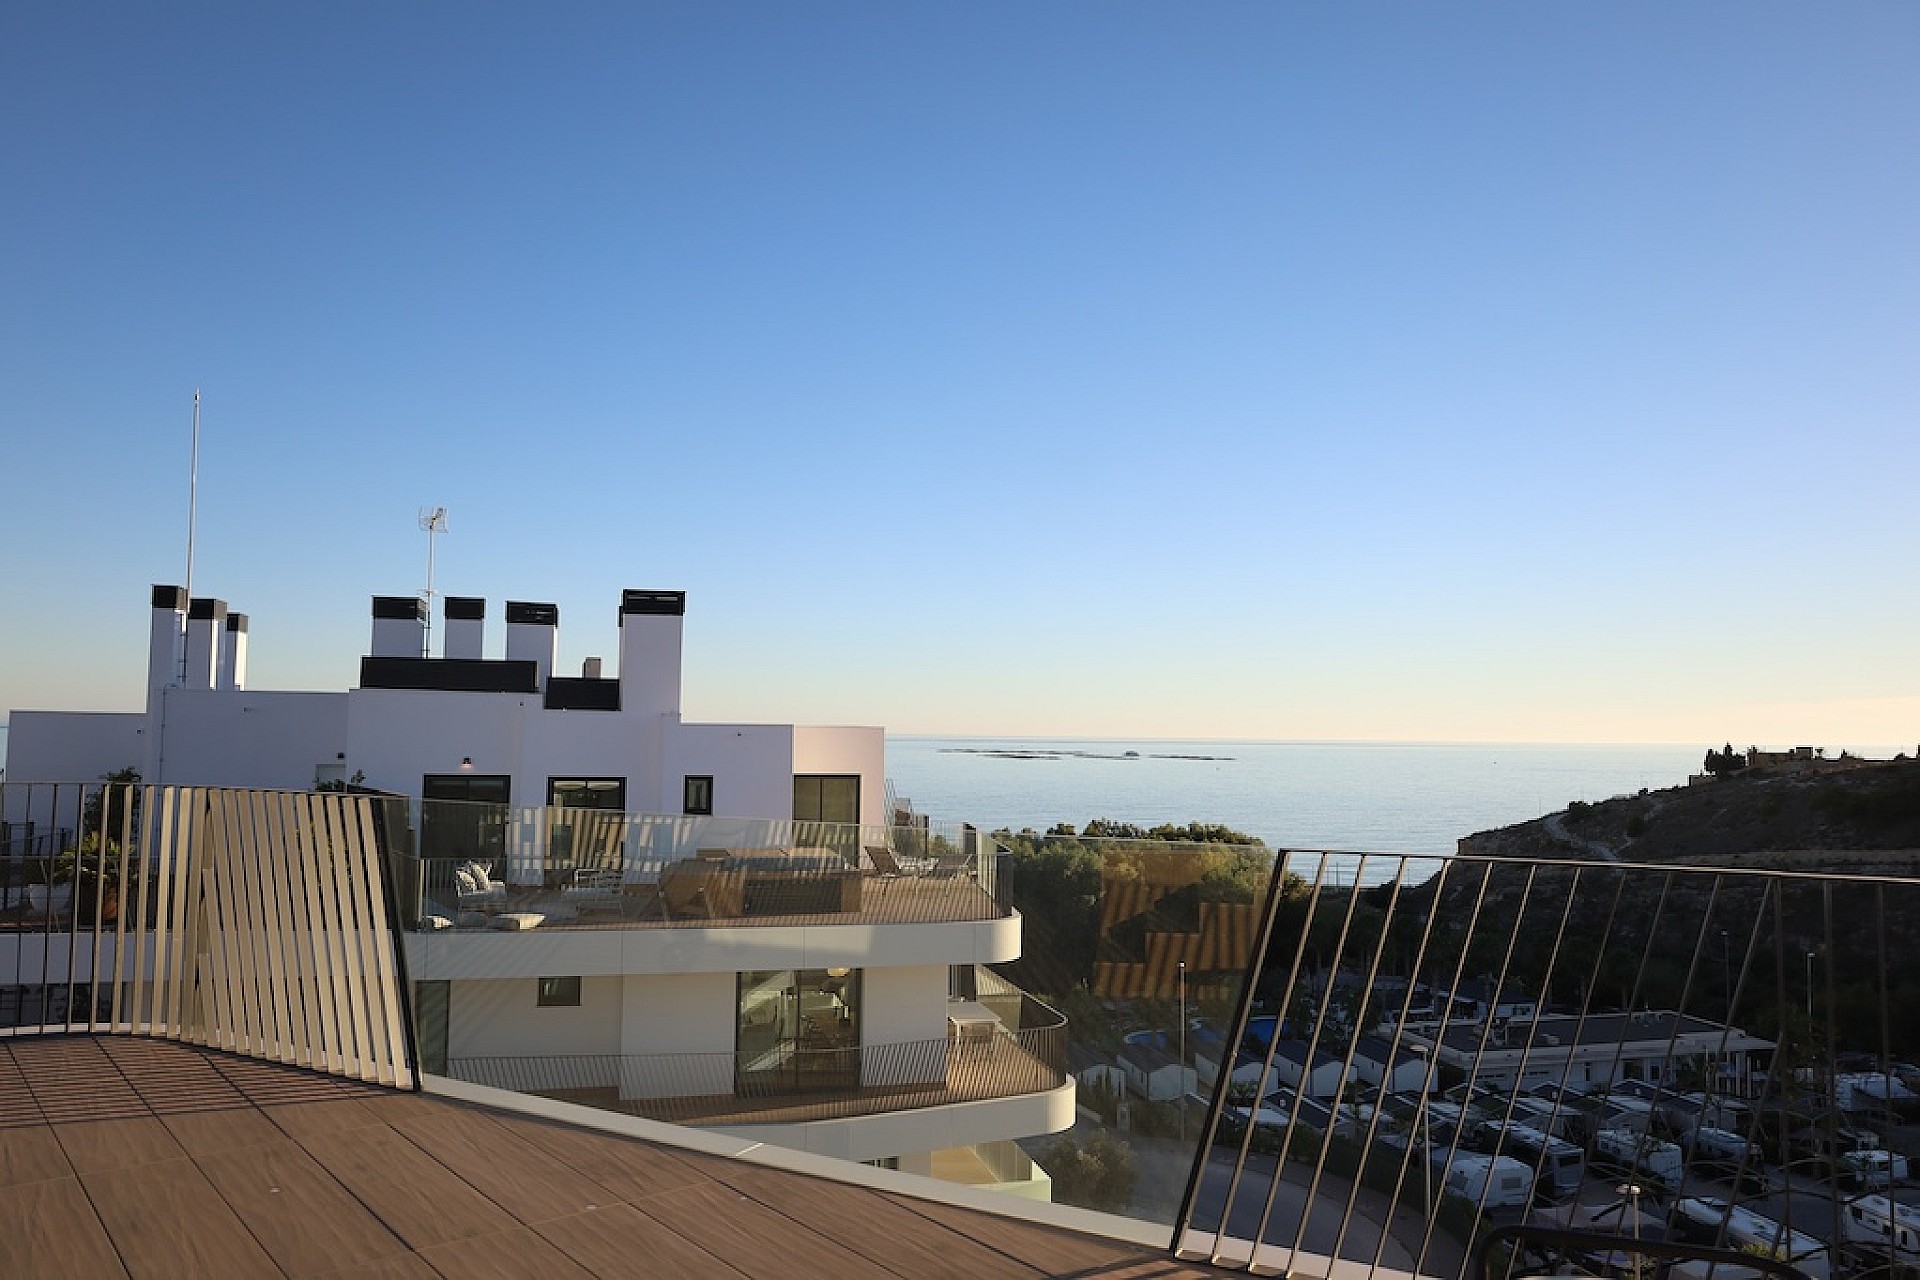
<box><xmin>733</xmin><ymin>969</ymin><xmax>860</xmax><ymax>1096</ymax></box>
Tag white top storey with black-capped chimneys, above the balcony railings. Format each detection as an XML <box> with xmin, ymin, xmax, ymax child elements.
<box><xmin>6</xmin><ymin>585</ymin><xmax>887</xmax><ymax>825</ymax></box>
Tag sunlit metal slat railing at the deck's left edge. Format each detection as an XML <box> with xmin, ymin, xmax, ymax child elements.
<box><xmin>0</xmin><ymin>783</ymin><xmax>413</xmax><ymax>1086</ymax></box>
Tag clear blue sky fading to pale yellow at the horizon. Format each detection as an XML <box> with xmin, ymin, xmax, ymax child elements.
<box><xmin>0</xmin><ymin>0</ymin><xmax>1920</xmax><ymax>750</ymax></box>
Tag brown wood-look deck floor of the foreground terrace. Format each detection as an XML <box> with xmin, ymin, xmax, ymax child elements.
<box><xmin>0</xmin><ymin>1036</ymin><xmax>1229</xmax><ymax>1280</ymax></box>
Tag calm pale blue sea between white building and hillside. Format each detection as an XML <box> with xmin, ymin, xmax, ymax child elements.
<box><xmin>887</xmin><ymin>735</ymin><xmax>1707</xmax><ymax>867</ymax></box>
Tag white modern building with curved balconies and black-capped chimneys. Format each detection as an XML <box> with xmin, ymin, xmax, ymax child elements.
<box><xmin>0</xmin><ymin>585</ymin><xmax>1073</xmax><ymax>1196</ymax></box>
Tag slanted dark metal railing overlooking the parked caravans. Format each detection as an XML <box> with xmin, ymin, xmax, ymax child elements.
<box><xmin>1179</xmin><ymin>852</ymin><xmax>1920</xmax><ymax>1276</ymax></box>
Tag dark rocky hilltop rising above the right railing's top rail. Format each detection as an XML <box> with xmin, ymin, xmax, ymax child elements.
<box><xmin>1459</xmin><ymin>760</ymin><xmax>1920</xmax><ymax>875</ymax></box>
